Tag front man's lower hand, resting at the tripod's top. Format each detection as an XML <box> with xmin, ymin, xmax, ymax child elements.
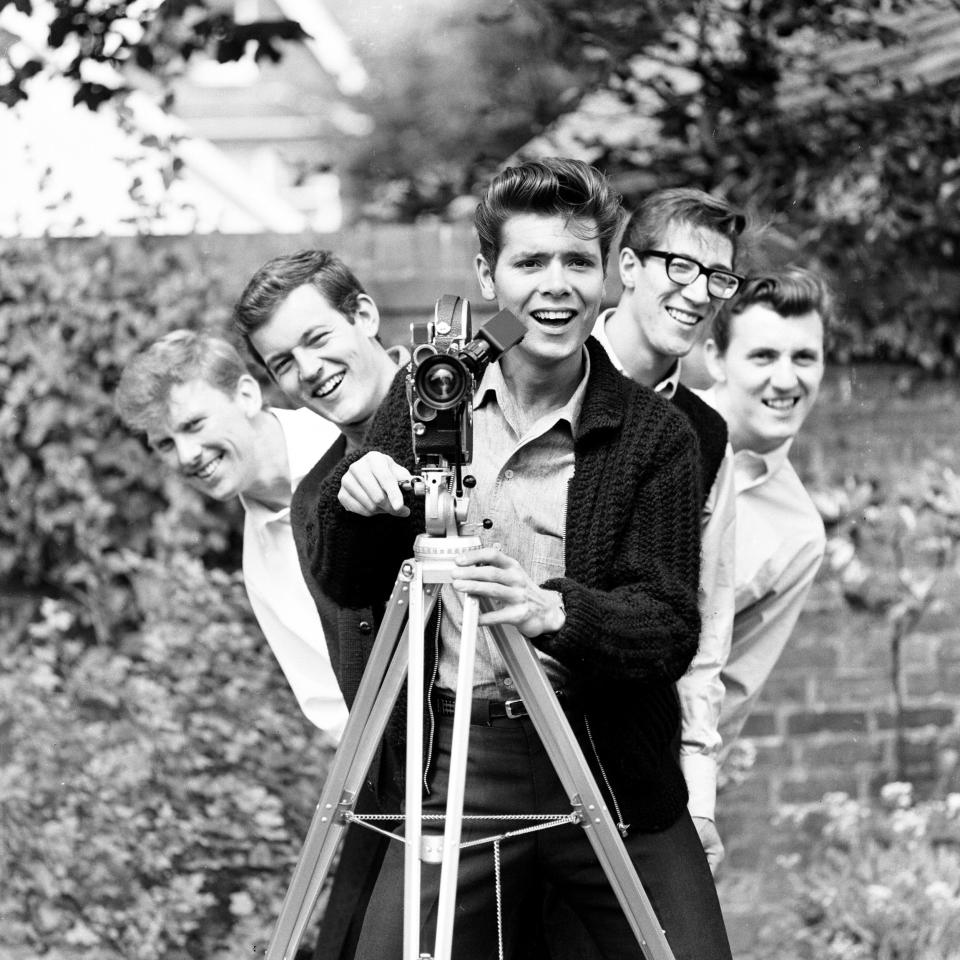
<box><xmin>453</xmin><ymin>547</ymin><xmax>566</xmax><ymax>637</ymax></box>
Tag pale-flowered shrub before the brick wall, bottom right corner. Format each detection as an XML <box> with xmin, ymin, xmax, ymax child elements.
<box><xmin>763</xmin><ymin>783</ymin><xmax>960</xmax><ymax>960</ymax></box>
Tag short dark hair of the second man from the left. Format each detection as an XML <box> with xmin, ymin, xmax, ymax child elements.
<box><xmin>233</xmin><ymin>250</ymin><xmax>367</xmax><ymax>362</ymax></box>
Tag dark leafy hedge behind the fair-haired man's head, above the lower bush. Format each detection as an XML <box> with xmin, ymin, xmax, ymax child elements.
<box><xmin>0</xmin><ymin>238</ymin><xmax>240</xmax><ymax>642</ymax></box>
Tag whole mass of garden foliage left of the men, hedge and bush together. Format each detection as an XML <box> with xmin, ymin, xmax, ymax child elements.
<box><xmin>0</xmin><ymin>239</ymin><xmax>330</xmax><ymax>960</ymax></box>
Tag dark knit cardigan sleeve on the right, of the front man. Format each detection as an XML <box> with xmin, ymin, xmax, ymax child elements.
<box><xmin>532</xmin><ymin>421</ymin><xmax>701</xmax><ymax>684</ymax></box>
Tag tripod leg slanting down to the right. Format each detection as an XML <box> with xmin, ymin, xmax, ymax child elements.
<box><xmin>483</xmin><ymin>612</ymin><xmax>674</xmax><ymax>960</ymax></box>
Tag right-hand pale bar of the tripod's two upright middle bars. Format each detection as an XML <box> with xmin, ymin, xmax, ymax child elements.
<box><xmin>434</xmin><ymin>596</ymin><xmax>480</xmax><ymax>960</ymax></box>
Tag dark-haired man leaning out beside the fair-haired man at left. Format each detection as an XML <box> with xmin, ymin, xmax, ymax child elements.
<box><xmin>233</xmin><ymin>249</ymin><xmax>407</xmax><ymax>960</ymax></box>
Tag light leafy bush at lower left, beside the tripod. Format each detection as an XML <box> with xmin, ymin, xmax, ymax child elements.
<box><xmin>0</xmin><ymin>552</ymin><xmax>330</xmax><ymax>960</ymax></box>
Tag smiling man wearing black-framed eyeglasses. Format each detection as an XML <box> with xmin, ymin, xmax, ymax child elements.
<box><xmin>593</xmin><ymin>189</ymin><xmax>746</xmax><ymax>871</ymax></box>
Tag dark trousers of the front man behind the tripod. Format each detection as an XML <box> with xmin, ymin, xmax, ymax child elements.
<box><xmin>357</xmin><ymin>718</ymin><xmax>730</xmax><ymax>960</ymax></box>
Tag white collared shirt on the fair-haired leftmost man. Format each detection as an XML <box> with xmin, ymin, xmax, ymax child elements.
<box><xmin>240</xmin><ymin>407</ymin><xmax>347</xmax><ymax>740</ymax></box>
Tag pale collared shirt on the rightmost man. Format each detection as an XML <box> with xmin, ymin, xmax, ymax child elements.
<box><xmin>702</xmin><ymin>387</ymin><xmax>826</xmax><ymax>747</ymax></box>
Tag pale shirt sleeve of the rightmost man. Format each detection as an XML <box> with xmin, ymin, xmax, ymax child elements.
<box><xmin>720</xmin><ymin>526</ymin><xmax>824</xmax><ymax>744</ymax></box>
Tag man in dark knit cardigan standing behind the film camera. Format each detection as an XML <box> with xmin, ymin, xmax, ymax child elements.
<box><xmin>298</xmin><ymin>159</ymin><xmax>730</xmax><ymax>960</ymax></box>
